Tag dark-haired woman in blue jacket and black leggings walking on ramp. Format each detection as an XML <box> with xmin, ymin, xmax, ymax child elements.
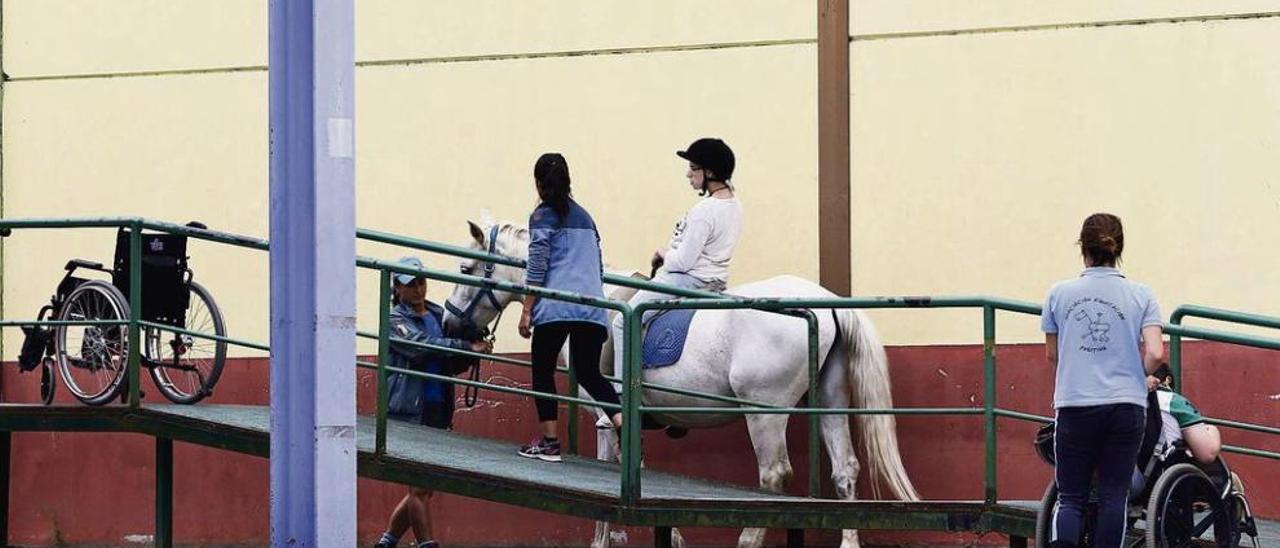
<box><xmin>520</xmin><ymin>152</ymin><xmax>622</xmax><ymax>462</ymax></box>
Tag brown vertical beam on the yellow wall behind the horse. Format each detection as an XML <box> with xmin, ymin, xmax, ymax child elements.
<box><xmin>818</xmin><ymin>0</ymin><xmax>852</xmax><ymax>296</ymax></box>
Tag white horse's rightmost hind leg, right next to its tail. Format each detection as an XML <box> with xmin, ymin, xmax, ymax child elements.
<box><xmin>818</xmin><ymin>356</ymin><xmax>860</xmax><ymax>548</ymax></box>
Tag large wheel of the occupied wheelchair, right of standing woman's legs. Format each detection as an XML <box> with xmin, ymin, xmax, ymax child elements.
<box><xmin>1146</xmin><ymin>463</ymin><xmax>1233</xmax><ymax>548</ymax></box>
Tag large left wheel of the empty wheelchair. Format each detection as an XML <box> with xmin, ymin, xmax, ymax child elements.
<box><xmin>50</xmin><ymin>280</ymin><xmax>129</xmax><ymax>406</ymax></box>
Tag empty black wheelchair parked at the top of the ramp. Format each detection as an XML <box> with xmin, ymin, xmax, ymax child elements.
<box><xmin>18</xmin><ymin>222</ymin><xmax>227</xmax><ymax>406</ymax></box>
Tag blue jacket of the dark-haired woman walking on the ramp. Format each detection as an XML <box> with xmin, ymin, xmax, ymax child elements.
<box><xmin>525</xmin><ymin>200</ymin><xmax>608</xmax><ymax>326</ymax></box>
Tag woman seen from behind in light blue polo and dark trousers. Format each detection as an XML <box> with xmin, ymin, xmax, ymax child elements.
<box><xmin>1041</xmin><ymin>213</ymin><xmax>1165</xmax><ymax>548</ymax></box>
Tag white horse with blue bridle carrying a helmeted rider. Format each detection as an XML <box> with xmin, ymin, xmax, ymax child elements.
<box><xmin>445</xmin><ymin>220</ymin><xmax>919</xmax><ymax>548</ymax></box>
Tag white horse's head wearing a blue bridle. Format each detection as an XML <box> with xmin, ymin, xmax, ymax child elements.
<box><xmin>444</xmin><ymin>215</ymin><xmax>529</xmax><ymax>339</ymax></box>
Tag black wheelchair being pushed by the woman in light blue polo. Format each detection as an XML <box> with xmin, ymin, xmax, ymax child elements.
<box><xmin>1036</xmin><ymin>393</ymin><xmax>1258</xmax><ymax>548</ymax></box>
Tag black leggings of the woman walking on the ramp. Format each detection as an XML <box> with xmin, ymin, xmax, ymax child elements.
<box><xmin>532</xmin><ymin>321</ymin><xmax>618</xmax><ymax>423</ymax></box>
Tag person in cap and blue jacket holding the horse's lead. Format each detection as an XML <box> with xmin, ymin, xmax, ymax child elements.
<box><xmin>375</xmin><ymin>257</ymin><xmax>493</xmax><ymax>548</ymax></box>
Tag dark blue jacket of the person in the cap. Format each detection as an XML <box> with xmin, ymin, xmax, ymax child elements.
<box><xmin>387</xmin><ymin>302</ymin><xmax>471</xmax><ymax>419</ymax></box>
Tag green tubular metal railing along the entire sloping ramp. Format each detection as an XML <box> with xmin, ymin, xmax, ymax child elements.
<box><xmin>0</xmin><ymin>218</ymin><xmax>1280</xmax><ymax>514</ymax></box>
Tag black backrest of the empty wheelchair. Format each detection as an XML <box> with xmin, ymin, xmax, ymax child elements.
<box><xmin>111</xmin><ymin>228</ymin><xmax>191</xmax><ymax>328</ymax></box>
